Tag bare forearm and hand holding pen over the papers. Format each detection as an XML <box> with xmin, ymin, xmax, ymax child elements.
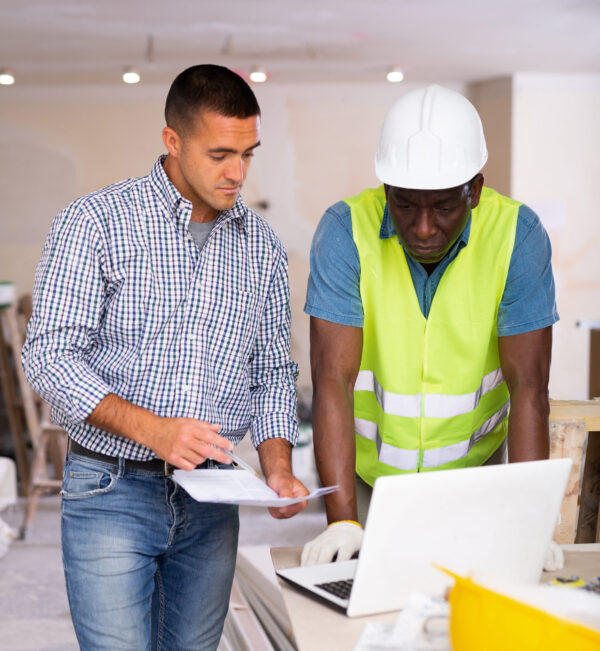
<box><xmin>87</xmin><ymin>393</ymin><xmax>234</xmax><ymax>470</ymax></box>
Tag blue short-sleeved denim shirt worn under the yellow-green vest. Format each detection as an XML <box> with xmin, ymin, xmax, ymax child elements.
<box><xmin>304</xmin><ymin>201</ymin><xmax>559</xmax><ymax>337</ymax></box>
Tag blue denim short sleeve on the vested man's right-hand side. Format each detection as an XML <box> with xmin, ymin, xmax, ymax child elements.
<box><xmin>498</xmin><ymin>205</ymin><xmax>559</xmax><ymax>337</ymax></box>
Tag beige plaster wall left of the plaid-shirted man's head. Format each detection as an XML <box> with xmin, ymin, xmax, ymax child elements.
<box><xmin>0</xmin><ymin>87</ymin><xmax>162</xmax><ymax>292</ymax></box>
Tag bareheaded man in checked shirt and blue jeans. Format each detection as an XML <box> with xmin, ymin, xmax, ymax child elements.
<box><xmin>23</xmin><ymin>65</ymin><xmax>308</xmax><ymax>650</ymax></box>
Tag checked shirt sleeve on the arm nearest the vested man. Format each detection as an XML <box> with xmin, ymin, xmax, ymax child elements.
<box><xmin>250</xmin><ymin>248</ymin><xmax>298</xmax><ymax>447</ymax></box>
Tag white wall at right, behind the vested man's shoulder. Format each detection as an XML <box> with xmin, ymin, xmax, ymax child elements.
<box><xmin>511</xmin><ymin>73</ymin><xmax>600</xmax><ymax>399</ymax></box>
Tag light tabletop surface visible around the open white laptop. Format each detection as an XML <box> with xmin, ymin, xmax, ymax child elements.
<box><xmin>271</xmin><ymin>544</ymin><xmax>600</xmax><ymax>651</ymax></box>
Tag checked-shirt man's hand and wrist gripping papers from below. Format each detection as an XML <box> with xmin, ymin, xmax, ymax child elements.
<box><xmin>258</xmin><ymin>438</ymin><xmax>309</xmax><ymax>520</ymax></box>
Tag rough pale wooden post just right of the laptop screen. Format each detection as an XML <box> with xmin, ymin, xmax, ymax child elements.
<box><xmin>550</xmin><ymin>420</ymin><xmax>587</xmax><ymax>544</ymax></box>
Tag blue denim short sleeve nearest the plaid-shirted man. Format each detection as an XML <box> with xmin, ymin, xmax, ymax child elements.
<box><xmin>304</xmin><ymin>201</ymin><xmax>363</xmax><ymax>328</ymax></box>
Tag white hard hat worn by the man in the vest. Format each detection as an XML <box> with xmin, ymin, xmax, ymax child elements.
<box><xmin>375</xmin><ymin>85</ymin><xmax>487</xmax><ymax>190</ymax></box>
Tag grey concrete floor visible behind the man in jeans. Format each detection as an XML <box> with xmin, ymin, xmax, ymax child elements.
<box><xmin>0</xmin><ymin>440</ymin><xmax>325</xmax><ymax>651</ymax></box>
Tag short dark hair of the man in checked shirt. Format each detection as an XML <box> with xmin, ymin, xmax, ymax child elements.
<box><xmin>165</xmin><ymin>63</ymin><xmax>260</xmax><ymax>135</ymax></box>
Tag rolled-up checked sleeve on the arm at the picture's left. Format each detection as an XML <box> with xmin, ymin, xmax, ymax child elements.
<box><xmin>22</xmin><ymin>202</ymin><xmax>110</xmax><ymax>424</ymax></box>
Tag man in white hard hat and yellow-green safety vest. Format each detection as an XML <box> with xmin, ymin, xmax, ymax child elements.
<box><xmin>302</xmin><ymin>86</ymin><xmax>558</xmax><ymax>564</ymax></box>
